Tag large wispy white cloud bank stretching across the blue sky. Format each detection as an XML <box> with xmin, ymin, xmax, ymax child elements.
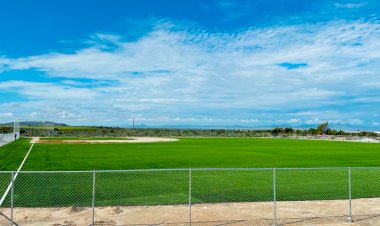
<box><xmin>0</xmin><ymin>21</ymin><xmax>380</xmax><ymax>128</ymax></box>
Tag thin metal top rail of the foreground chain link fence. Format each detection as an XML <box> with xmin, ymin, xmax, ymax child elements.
<box><xmin>0</xmin><ymin>166</ymin><xmax>380</xmax><ymax>174</ymax></box>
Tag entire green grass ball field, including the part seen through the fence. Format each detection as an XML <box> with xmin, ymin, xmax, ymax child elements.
<box><xmin>0</xmin><ymin>138</ymin><xmax>380</xmax><ymax>206</ymax></box>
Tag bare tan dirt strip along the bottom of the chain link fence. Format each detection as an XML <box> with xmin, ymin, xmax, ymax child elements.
<box><xmin>0</xmin><ymin>198</ymin><xmax>380</xmax><ymax>226</ymax></box>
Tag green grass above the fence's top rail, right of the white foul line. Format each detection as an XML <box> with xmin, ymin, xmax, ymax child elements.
<box><xmin>17</xmin><ymin>138</ymin><xmax>380</xmax><ymax>170</ymax></box>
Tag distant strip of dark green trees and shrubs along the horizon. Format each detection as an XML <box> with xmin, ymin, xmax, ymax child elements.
<box><xmin>0</xmin><ymin>122</ymin><xmax>379</xmax><ymax>137</ymax></box>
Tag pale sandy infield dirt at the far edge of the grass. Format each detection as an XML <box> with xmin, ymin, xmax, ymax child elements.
<box><xmin>30</xmin><ymin>137</ymin><xmax>178</xmax><ymax>144</ymax></box>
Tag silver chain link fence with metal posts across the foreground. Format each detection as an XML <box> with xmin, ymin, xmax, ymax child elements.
<box><xmin>0</xmin><ymin>167</ymin><xmax>380</xmax><ymax>226</ymax></box>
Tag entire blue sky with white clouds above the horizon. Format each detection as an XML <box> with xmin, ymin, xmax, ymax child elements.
<box><xmin>0</xmin><ymin>0</ymin><xmax>380</xmax><ymax>130</ymax></box>
